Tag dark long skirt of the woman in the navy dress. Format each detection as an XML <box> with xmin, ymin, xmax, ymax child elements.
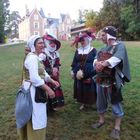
<box><xmin>74</xmin><ymin>79</ymin><xmax>96</xmax><ymax>105</ymax></box>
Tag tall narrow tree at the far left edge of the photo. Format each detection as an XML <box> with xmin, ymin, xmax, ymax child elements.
<box><xmin>0</xmin><ymin>0</ymin><xmax>10</xmax><ymax>43</ymax></box>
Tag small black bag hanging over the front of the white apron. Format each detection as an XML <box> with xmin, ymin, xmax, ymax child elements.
<box><xmin>35</xmin><ymin>87</ymin><xmax>47</xmax><ymax>103</ymax></box>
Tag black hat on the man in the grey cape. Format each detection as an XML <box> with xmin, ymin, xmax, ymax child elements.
<box><xmin>102</xmin><ymin>26</ymin><xmax>117</xmax><ymax>37</ymax></box>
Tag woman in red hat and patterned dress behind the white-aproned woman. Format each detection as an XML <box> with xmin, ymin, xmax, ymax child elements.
<box><xmin>40</xmin><ymin>34</ymin><xmax>64</xmax><ymax>110</ymax></box>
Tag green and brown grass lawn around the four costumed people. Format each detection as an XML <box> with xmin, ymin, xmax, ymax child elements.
<box><xmin>0</xmin><ymin>42</ymin><xmax>140</xmax><ymax>140</ymax></box>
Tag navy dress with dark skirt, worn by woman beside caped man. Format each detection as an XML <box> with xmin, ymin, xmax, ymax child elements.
<box><xmin>71</xmin><ymin>46</ymin><xmax>96</xmax><ymax>105</ymax></box>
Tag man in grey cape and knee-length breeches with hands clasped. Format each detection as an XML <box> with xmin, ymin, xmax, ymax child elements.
<box><xmin>92</xmin><ymin>26</ymin><xmax>130</xmax><ymax>139</ymax></box>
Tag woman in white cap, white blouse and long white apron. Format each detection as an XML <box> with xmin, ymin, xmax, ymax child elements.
<box><xmin>18</xmin><ymin>35</ymin><xmax>59</xmax><ymax>140</ymax></box>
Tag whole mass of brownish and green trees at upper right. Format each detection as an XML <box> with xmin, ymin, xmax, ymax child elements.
<box><xmin>85</xmin><ymin>0</ymin><xmax>140</xmax><ymax>40</ymax></box>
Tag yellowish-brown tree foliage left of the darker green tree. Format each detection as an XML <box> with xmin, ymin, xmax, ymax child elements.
<box><xmin>85</xmin><ymin>0</ymin><xmax>120</xmax><ymax>31</ymax></box>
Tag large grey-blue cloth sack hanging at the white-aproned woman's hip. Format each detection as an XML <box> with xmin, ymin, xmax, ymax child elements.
<box><xmin>15</xmin><ymin>85</ymin><xmax>33</xmax><ymax>128</ymax></box>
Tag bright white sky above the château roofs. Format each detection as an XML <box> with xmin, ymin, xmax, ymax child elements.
<box><xmin>9</xmin><ymin>0</ymin><xmax>103</xmax><ymax>20</ymax></box>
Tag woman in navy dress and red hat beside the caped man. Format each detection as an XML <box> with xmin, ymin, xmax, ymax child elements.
<box><xmin>71</xmin><ymin>31</ymin><xmax>96</xmax><ymax>110</ymax></box>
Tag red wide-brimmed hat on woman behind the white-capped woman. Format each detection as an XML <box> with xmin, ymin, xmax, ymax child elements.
<box><xmin>43</xmin><ymin>34</ymin><xmax>61</xmax><ymax>50</ymax></box>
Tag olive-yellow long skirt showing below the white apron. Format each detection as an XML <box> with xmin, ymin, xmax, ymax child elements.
<box><xmin>17</xmin><ymin>120</ymin><xmax>46</xmax><ymax>140</ymax></box>
